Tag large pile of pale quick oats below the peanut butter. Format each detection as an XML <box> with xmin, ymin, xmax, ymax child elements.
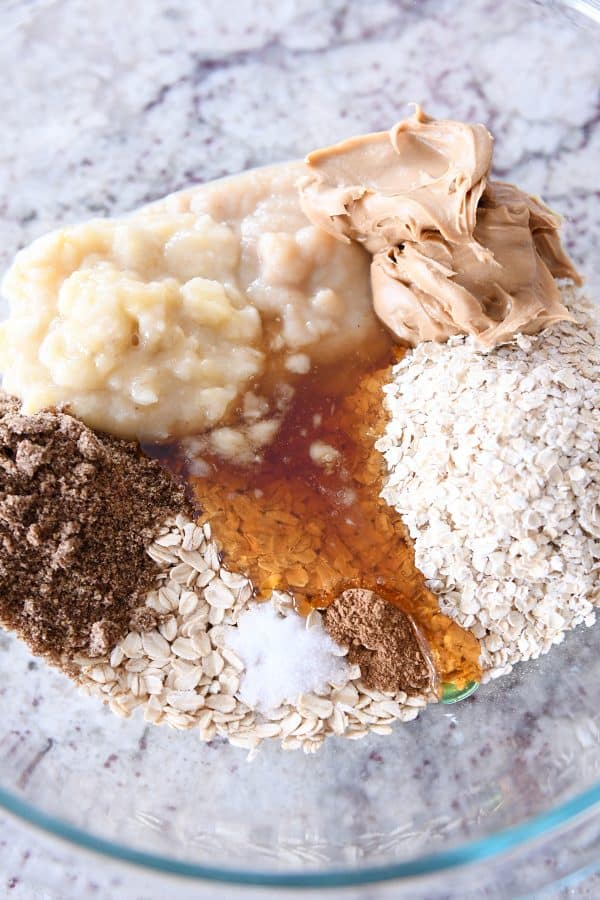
<box><xmin>377</xmin><ymin>291</ymin><xmax>600</xmax><ymax>680</ymax></box>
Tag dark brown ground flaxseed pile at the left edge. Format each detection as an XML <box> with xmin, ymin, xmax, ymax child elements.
<box><xmin>0</xmin><ymin>394</ymin><xmax>187</xmax><ymax>664</ymax></box>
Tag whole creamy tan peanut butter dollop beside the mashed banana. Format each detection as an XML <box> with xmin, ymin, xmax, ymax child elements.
<box><xmin>300</xmin><ymin>106</ymin><xmax>581</xmax><ymax>348</ymax></box>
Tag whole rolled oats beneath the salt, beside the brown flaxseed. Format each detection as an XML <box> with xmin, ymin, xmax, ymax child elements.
<box><xmin>75</xmin><ymin>516</ymin><xmax>436</xmax><ymax>754</ymax></box>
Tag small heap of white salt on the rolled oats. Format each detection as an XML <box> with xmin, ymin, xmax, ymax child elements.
<box><xmin>225</xmin><ymin>603</ymin><xmax>349</xmax><ymax>713</ymax></box>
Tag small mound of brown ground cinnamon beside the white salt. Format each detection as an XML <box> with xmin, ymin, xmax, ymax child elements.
<box><xmin>323</xmin><ymin>588</ymin><xmax>436</xmax><ymax>693</ymax></box>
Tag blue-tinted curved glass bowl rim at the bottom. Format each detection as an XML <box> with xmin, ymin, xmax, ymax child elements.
<box><xmin>0</xmin><ymin>783</ymin><xmax>600</xmax><ymax>889</ymax></box>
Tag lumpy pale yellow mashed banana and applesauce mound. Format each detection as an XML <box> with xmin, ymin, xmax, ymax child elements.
<box><xmin>0</xmin><ymin>164</ymin><xmax>385</xmax><ymax>442</ymax></box>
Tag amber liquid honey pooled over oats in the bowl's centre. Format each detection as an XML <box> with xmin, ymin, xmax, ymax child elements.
<box><xmin>148</xmin><ymin>354</ymin><xmax>480</xmax><ymax>688</ymax></box>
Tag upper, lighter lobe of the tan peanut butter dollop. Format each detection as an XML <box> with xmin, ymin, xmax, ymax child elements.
<box><xmin>300</xmin><ymin>106</ymin><xmax>493</xmax><ymax>254</ymax></box>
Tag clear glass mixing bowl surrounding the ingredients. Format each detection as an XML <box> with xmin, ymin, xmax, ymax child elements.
<box><xmin>0</xmin><ymin>0</ymin><xmax>600</xmax><ymax>896</ymax></box>
